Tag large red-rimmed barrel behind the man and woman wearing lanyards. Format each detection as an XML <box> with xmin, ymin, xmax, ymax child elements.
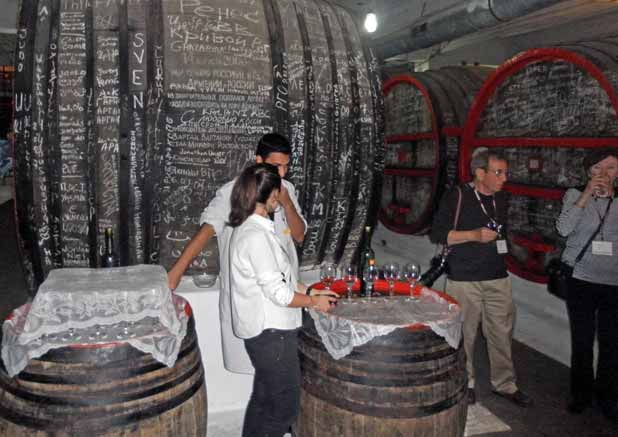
<box><xmin>459</xmin><ymin>39</ymin><xmax>618</xmax><ymax>283</ymax></box>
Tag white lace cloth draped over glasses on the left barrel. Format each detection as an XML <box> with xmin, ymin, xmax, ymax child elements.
<box><xmin>2</xmin><ymin>265</ymin><xmax>188</xmax><ymax>376</ymax></box>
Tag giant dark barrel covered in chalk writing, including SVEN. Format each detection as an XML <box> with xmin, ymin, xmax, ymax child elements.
<box><xmin>15</xmin><ymin>0</ymin><xmax>383</xmax><ymax>289</ymax></box>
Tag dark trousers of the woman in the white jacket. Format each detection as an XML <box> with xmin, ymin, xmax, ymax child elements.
<box><xmin>242</xmin><ymin>329</ymin><xmax>300</xmax><ymax>437</ymax></box>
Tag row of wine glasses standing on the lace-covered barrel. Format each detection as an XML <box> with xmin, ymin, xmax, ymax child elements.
<box><xmin>320</xmin><ymin>262</ymin><xmax>421</xmax><ymax>298</ymax></box>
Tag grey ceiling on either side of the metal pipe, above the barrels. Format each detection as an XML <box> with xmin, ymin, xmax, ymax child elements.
<box><xmin>0</xmin><ymin>0</ymin><xmax>618</xmax><ymax>65</ymax></box>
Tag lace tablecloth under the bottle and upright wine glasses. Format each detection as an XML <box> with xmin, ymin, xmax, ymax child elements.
<box><xmin>309</xmin><ymin>288</ymin><xmax>463</xmax><ymax>360</ymax></box>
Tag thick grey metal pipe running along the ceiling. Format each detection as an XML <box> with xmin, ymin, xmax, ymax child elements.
<box><xmin>369</xmin><ymin>0</ymin><xmax>565</xmax><ymax>59</ymax></box>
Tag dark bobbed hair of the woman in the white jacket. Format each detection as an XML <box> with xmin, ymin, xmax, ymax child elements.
<box><xmin>228</xmin><ymin>163</ymin><xmax>281</xmax><ymax>227</ymax></box>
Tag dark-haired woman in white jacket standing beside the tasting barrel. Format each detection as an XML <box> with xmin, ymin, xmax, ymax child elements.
<box><xmin>229</xmin><ymin>164</ymin><xmax>336</xmax><ymax>437</ymax></box>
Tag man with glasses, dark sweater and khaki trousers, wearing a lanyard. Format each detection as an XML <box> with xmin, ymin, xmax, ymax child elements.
<box><xmin>430</xmin><ymin>148</ymin><xmax>532</xmax><ymax>407</ymax></box>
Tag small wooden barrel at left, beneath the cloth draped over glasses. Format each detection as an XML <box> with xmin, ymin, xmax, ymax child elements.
<box><xmin>0</xmin><ymin>308</ymin><xmax>207</xmax><ymax>437</ymax></box>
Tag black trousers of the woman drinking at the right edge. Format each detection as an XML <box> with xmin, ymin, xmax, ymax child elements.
<box><xmin>566</xmin><ymin>278</ymin><xmax>618</xmax><ymax>408</ymax></box>
